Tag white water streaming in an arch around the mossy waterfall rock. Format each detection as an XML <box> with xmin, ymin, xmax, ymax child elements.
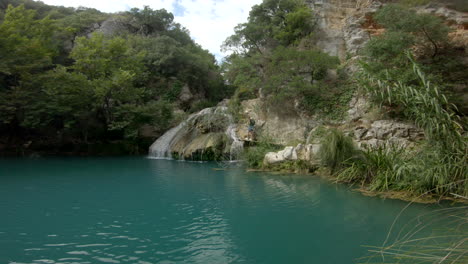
<box><xmin>149</xmin><ymin>106</ymin><xmax>244</xmax><ymax>161</ymax></box>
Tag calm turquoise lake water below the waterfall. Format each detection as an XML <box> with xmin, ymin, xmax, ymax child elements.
<box><xmin>0</xmin><ymin>157</ymin><xmax>456</xmax><ymax>264</ymax></box>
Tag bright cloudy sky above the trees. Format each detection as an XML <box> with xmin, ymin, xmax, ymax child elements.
<box><xmin>37</xmin><ymin>0</ymin><xmax>262</xmax><ymax>60</ymax></box>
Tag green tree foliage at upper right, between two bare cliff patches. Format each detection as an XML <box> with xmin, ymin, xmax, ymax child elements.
<box><xmin>365</xmin><ymin>4</ymin><xmax>449</xmax><ymax>82</ymax></box>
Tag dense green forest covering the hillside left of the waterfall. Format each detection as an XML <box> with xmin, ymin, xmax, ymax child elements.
<box><xmin>0</xmin><ymin>0</ymin><xmax>229</xmax><ymax>155</ymax></box>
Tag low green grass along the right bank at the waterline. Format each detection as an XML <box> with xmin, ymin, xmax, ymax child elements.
<box><xmin>337</xmin><ymin>142</ymin><xmax>468</xmax><ymax>196</ymax></box>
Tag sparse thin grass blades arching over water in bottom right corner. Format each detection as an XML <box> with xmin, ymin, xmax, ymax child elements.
<box><xmin>357</xmin><ymin>206</ymin><xmax>468</xmax><ymax>264</ymax></box>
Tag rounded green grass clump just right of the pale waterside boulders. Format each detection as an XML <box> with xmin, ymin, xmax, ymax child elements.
<box><xmin>318</xmin><ymin>129</ymin><xmax>357</xmax><ymax>174</ymax></box>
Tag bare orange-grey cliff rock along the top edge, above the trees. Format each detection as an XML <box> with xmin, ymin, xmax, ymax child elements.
<box><xmin>307</xmin><ymin>0</ymin><xmax>468</xmax><ymax>60</ymax></box>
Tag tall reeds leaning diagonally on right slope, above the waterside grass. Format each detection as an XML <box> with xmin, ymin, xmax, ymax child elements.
<box><xmin>361</xmin><ymin>53</ymin><xmax>466</xmax><ymax>151</ymax></box>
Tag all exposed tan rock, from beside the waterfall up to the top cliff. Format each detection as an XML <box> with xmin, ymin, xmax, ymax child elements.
<box><xmin>149</xmin><ymin>0</ymin><xmax>468</xmax><ymax>165</ymax></box>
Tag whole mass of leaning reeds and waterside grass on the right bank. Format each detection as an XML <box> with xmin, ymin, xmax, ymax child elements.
<box><xmin>354</xmin><ymin>53</ymin><xmax>468</xmax><ymax>196</ymax></box>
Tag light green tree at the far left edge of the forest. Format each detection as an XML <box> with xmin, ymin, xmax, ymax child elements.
<box><xmin>0</xmin><ymin>5</ymin><xmax>55</xmax><ymax>130</ymax></box>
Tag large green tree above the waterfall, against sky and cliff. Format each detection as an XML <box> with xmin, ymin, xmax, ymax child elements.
<box><xmin>222</xmin><ymin>0</ymin><xmax>348</xmax><ymax>116</ymax></box>
